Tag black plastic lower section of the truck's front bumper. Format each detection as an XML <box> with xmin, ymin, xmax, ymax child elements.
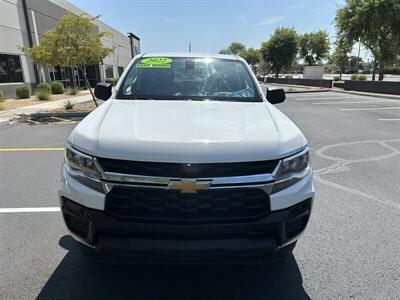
<box><xmin>61</xmin><ymin>197</ymin><xmax>312</xmax><ymax>257</ymax></box>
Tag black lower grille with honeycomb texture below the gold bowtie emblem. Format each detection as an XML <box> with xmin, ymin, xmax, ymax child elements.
<box><xmin>105</xmin><ymin>187</ymin><xmax>269</xmax><ymax>224</ymax></box>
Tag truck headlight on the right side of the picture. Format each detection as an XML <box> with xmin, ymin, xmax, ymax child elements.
<box><xmin>271</xmin><ymin>147</ymin><xmax>309</xmax><ymax>193</ymax></box>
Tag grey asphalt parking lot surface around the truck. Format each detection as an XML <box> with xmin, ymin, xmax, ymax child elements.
<box><xmin>0</xmin><ymin>92</ymin><xmax>400</xmax><ymax>299</ymax></box>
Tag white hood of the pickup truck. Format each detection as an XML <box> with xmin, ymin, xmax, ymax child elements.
<box><xmin>69</xmin><ymin>99</ymin><xmax>307</xmax><ymax>163</ymax></box>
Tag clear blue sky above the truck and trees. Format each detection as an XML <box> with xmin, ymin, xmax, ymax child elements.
<box><xmin>69</xmin><ymin>0</ymin><xmax>368</xmax><ymax>57</ymax></box>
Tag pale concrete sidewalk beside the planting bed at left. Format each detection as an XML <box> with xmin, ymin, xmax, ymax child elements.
<box><xmin>0</xmin><ymin>94</ymin><xmax>92</xmax><ymax>124</ymax></box>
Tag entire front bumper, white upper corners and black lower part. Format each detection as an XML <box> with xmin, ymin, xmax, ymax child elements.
<box><xmin>59</xmin><ymin>161</ymin><xmax>314</xmax><ymax>259</ymax></box>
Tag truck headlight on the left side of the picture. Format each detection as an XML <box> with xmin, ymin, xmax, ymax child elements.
<box><xmin>65</xmin><ymin>146</ymin><xmax>104</xmax><ymax>193</ymax></box>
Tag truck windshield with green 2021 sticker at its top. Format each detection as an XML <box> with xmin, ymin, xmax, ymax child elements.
<box><xmin>117</xmin><ymin>57</ymin><xmax>262</xmax><ymax>102</ymax></box>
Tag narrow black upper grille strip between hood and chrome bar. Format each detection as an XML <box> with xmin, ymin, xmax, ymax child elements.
<box><xmin>97</xmin><ymin>157</ymin><xmax>279</xmax><ymax>178</ymax></box>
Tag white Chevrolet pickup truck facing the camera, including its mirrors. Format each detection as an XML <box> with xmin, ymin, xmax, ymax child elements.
<box><xmin>59</xmin><ymin>53</ymin><xmax>314</xmax><ymax>261</ymax></box>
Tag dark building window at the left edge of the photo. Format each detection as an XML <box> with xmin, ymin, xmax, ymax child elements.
<box><xmin>0</xmin><ymin>54</ymin><xmax>24</xmax><ymax>83</ymax></box>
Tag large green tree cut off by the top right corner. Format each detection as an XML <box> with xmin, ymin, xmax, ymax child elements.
<box><xmin>335</xmin><ymin>0</ymin><xmax>400</xmax><ymax>80</ymax></box>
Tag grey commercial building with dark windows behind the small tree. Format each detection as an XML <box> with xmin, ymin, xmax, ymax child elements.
<box><xmin>0</xmin><ymin>0</ymin><xmax>140</xmax><ymax>97</ymax></box>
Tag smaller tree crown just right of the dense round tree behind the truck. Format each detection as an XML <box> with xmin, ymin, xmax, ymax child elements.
<box><xmin>299</xmin><ymin>30</ymin><xmax>329</xmax><ymax>66</ymax></box>
